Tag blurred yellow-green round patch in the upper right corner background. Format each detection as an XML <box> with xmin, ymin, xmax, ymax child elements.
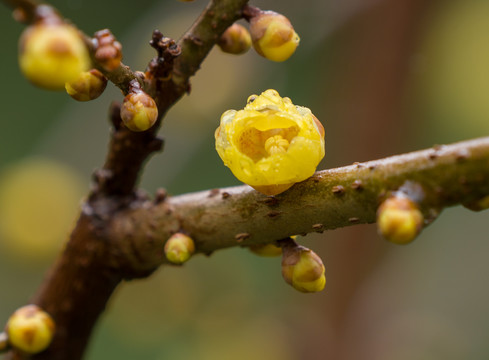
<box><xmin>412</xmin><ymin>0</ymin><xmax>489</xmax><ymax>143</ymax></box>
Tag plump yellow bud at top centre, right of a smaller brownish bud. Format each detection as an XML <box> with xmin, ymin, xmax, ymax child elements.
<box><xmin>250</xmin><ymin>11</ymin><xmax>300</xmax><ymax>61</ymax></box>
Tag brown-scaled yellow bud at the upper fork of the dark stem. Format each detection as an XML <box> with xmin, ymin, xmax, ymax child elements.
<box><xmin>121</xmin><ymin>90</ymin><xmax>158</xmax><ymax>132</ymax></box>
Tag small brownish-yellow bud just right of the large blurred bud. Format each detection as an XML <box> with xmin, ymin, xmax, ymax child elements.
<box><xmin>65</xmin><ymin>69</ymin><xmax>107</xmax><ymax>101</ymax></box>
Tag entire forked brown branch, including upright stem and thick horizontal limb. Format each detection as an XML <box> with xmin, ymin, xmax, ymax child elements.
<box><xmin>4</xmin><ymin>0</ymin><xmax>489</xmax><ymax>360</ymax></box>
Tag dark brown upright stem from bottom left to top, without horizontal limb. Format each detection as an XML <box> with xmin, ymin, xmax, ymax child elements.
<box><xmin>0</xmin><ymin>0</ymin><xmax>247</xmax><ymax>360</ymax></box>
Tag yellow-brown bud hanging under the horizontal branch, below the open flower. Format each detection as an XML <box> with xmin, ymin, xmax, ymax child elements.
<box><xmin>282</xmin><ymin>243</ymin><xmax>326</xmax><ymax>293</ymax></box>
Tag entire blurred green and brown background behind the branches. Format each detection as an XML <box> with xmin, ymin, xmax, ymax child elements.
<box><xmin>0</xmin><ymin>0</ymin><xmax>489</xmax><ymax>360</ymax></box>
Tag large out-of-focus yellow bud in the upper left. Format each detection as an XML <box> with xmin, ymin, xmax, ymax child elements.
<box><xmin>19</xmin><ymin>22</ymin><xmax>91</xmax><ymax>90</ymax></box>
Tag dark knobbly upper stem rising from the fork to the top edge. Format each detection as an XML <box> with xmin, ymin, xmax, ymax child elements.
<box><xmin>92</xmin><ymin>0</ymin><xmax>248</xmax><ymax>197</ymax></box>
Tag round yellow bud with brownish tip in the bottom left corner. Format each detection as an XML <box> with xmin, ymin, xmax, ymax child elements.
<box><xmin>6</xmin><ymin>305</ymin><xmax>55</xmax><ymax>354</ymax></box>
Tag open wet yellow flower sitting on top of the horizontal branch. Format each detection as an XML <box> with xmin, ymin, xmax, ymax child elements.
<box><xmin>215</xmin><ymin>90</ymin><xmax>324</xmax><ymax>195</ymax></box>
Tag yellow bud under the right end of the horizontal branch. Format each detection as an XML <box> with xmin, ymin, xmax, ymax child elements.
<box><xmin>377</xmin><ymin>195</ymin><xmax>423</xmax><ymax>244</ymax></box>
